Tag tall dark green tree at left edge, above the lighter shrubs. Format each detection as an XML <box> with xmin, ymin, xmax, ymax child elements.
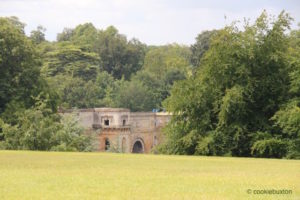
<box><xmin>0</xmin><ymin>18</ymin><xmax>56</xmax><ymax>113</ymax></box>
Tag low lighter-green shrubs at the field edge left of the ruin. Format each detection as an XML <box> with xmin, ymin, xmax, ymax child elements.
<box><xmin>0</xmin><ymin>98</ymin><xmax>93</xmax><ymax>151</ymax></box>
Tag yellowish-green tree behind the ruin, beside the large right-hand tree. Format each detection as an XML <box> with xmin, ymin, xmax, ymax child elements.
<box><xmin>126</xmin><ymin>44</ymin><xmax>191</xmax><ymax>111</ymax></box>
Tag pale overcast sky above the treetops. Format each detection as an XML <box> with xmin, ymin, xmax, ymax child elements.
<box><xmin>0</xmin><ymin>0</ymin><xmax>300</xmax><ymax>45</ymax></box>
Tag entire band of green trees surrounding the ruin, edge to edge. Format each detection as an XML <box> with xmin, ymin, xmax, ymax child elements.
<box><xmin>0</xmin><ymin>12</ymin><xmax>300</xmax><ymax>158</ymax></box>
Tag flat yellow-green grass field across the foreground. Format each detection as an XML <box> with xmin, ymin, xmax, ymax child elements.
<box><xmin>0</xmin><ymin>151</ymin><xmax>300</xmax><ymax>200</ymax></box>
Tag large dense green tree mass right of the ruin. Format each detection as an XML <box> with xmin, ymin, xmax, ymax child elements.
<box><xmin>161</xmin><ymin>12</ymin><xmax>300</xmax><ymax>158</ymax></box>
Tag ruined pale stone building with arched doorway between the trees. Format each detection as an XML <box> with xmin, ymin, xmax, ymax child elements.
<box><xmin>60</xmin><ymin>108</ymin><xmax>171</xmax><ymax>153</ymax></box>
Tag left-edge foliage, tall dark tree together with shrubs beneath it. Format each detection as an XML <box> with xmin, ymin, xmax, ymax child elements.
<box><xmin>0</xmin><ymin>18</ymin><xmax>92</xmax><ymax>151</ymax></box>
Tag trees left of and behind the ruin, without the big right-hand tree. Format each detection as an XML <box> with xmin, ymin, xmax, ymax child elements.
<box><xmin>0</xmin><ymin>17</ymin><xmax>195</xmax><ymax>151</ymax></box>
